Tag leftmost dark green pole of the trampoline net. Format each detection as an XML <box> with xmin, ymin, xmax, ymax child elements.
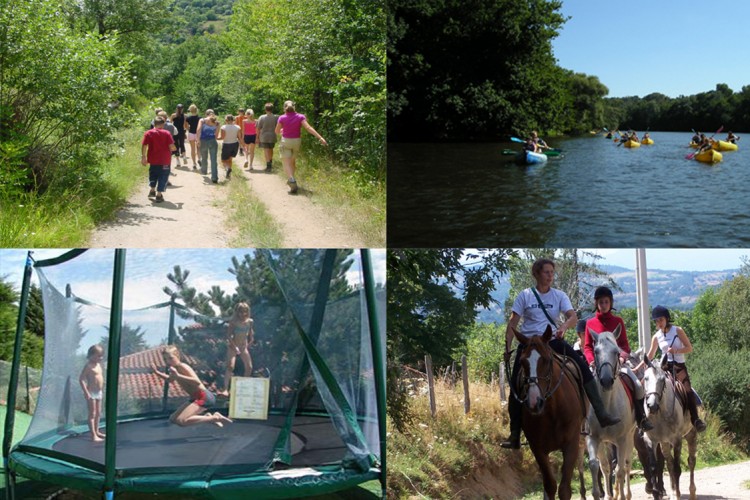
<box><xmin>3</xmin><ymin>252</ymin><xmax>32</xmax><ymax>499</ymax></box>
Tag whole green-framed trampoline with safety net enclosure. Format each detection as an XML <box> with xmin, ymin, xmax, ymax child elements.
<box><xmin>3</xmin><ymin>250</ymin><xmax>385</xmax><ymax>499</ymax></box>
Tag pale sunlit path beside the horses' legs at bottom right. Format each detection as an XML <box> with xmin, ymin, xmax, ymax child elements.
<box><xmin>628</xmin><ymin>461</ymin><xmax>750</xmax><ymax>500</ymax></box>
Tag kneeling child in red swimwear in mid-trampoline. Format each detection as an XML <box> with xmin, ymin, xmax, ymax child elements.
<box><xmin>151</xmin><ymin>345</ymin><xmax>232</xmax><ymax>427</ymax></box>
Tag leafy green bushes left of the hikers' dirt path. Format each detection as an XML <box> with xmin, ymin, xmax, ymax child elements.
<box><xmin>0</xmin><ymin>0</ymin><xmax>130</xmax><ymax>195</ymax></box>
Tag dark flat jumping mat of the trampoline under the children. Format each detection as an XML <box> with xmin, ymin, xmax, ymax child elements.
<box><xmin>53</xmin><ymin>416</ymin><xmax>354</xmax><ymax>469</ymax></box>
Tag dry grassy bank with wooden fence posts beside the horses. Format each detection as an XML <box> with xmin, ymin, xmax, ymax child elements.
<box><xmin>388</xmin><ymin>380</ymin><xmax>747</xmax><ymax>499</ymax></box>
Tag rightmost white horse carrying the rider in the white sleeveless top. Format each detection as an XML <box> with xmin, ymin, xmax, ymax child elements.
<box><xmin>643</xmin><ymin>361</ymin><xmax>698</xmax><ymax>500</ymax></box>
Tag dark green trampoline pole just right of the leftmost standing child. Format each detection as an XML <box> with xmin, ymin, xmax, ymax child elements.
<box><xmin>103</xmin><ymin>248</ymin><xmax>125</xmax><ymax>499</ymax></box>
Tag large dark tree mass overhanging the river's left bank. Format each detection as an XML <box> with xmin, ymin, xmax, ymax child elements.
<box><xmin>388</xmin><ymin>0</ymin><xmax>570</xmax><ymax>140</ymax></box>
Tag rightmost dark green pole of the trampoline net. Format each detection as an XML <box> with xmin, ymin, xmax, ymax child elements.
<box><xmin>361</xmin><ymin>248</ymin><xmax>386</xmax><ymax>498</ymax></box>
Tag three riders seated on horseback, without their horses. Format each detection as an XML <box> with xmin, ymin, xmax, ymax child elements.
<box><xmin>501</xmin><ymin>259</ymin><xmax>706</xmax><ymax>449</ymax></box>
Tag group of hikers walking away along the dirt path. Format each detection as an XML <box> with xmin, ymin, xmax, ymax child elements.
<box><xmin>141</xmin><ymin>101</ymin><xmax>328</xmax><ymax>202</ymax></box>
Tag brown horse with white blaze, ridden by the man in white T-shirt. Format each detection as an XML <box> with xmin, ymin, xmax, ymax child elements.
<box><xmin>514</xmin><ymin>326</ymin><xmax>587</xmax><ymax>500</ymax></box>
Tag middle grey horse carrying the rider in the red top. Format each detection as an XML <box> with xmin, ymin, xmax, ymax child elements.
<box><xmin>586</xmin><ymin>325</ymin><xmax>636</xmax><ymax>500</ymax></box>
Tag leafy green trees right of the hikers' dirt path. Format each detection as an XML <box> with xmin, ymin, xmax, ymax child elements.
<box><xmin>225</xmin><ymin>0</ymin><xmax>386</xmax><ymax>188</ymax></box>
